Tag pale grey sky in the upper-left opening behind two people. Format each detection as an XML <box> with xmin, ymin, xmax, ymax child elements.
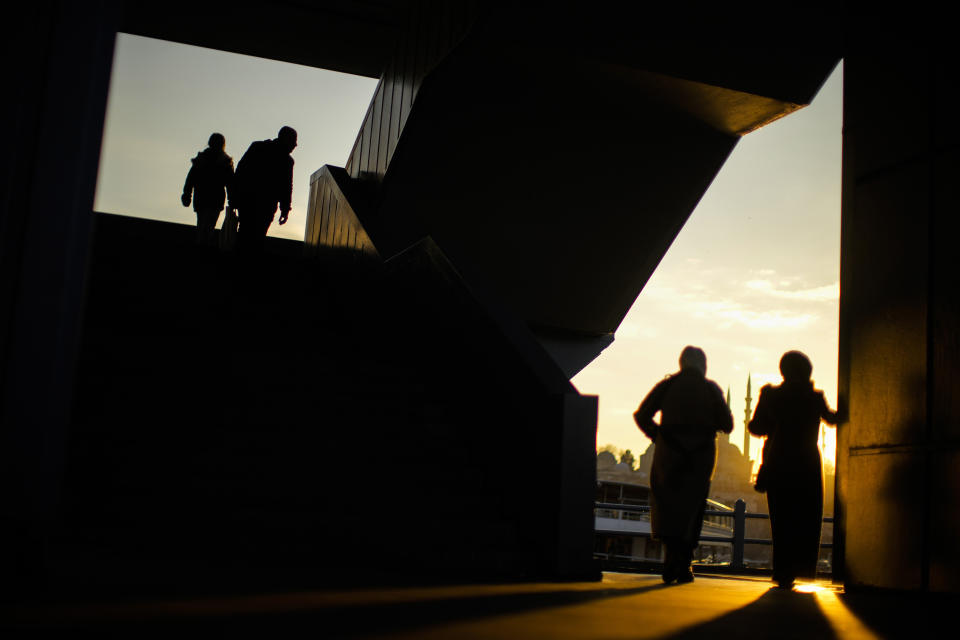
<box><xmin>94</xmin><ymin>34</ymin><xmax>377</xmax><ymax>240</ymax></box>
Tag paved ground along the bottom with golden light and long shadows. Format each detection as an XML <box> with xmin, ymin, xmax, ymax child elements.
<box><xmin>0</xmin><ymin>573</ymin><xmax>956</xmax><ymax>640</ymax></box>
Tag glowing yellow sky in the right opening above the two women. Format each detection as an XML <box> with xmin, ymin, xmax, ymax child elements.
<box><xmin>573</xmin><ymin>65</ymin><xmax>843</xmax><ymax>468</ymax></box>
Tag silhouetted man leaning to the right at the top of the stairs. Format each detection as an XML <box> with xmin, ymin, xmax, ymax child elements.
<box><xmin>231</xmin><ymin>127</ymin><xmax>297</xmax><ymax>252</ymax></box>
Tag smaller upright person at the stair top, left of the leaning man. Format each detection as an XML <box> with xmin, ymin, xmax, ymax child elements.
<box><xmin>180</xmin><ymin>133</ymin><xmax>233</xmax><ymax>245</ymax></box>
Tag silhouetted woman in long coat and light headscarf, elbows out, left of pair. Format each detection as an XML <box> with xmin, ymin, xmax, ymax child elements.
<box><xmin>633</xmin><ymin>347</ymin><xmax>733</xmax><ymax>584</ymax></box>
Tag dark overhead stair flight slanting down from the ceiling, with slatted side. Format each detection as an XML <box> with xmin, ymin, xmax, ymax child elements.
<box><xmin>306</xmin><ymin>1</ymin><xmax>837</xmax><ymax>377</ymax></box>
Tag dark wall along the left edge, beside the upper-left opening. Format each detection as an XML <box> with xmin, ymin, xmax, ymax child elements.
<box><xmin>0</xmin><ymin>2</ymin><xmax>117</xmax><ymax>592</ymax></box>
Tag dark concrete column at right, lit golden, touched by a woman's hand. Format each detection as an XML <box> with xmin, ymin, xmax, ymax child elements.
<box><xmin>837</xmin><ymin>45</ymin><xmax>960</xmax><ymax>591</ymax></box>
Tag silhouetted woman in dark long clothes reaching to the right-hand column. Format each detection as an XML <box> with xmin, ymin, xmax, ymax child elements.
<box><xmin>749</xmin><ymin>351</ymin><xmax>837</xmax><ymax>589</ymax></box>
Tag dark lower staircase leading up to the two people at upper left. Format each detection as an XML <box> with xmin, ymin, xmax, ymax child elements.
<box><xmin>60</xmin><ymin>214</ymin><xmax>596</xmax><ymax>592</ymax></box>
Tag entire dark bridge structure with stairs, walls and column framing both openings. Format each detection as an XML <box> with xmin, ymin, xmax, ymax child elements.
<box><xmin>0</xmin><ymin>0</ymin><xmax>960</xmax><ymax>593</ymax></box>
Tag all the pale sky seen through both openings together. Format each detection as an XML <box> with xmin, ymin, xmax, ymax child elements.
<box><xmin>94</xmin><ymin>34</ymin><xmax>842</xmax><ymax>464</ymax></box>
